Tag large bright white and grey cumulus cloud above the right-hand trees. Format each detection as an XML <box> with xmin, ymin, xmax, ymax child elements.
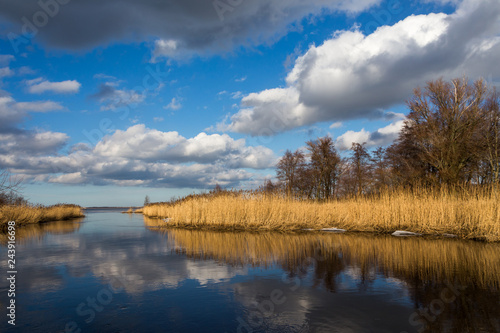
<box><xmin>221</xmin><ymin>0</ymin><xmax>500</xmax><ymax>136</ymax></box>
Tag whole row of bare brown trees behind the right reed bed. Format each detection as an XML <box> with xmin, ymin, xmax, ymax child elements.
<box><xmin>268</xmin><ymin>78</ymin><xmax>500</xmax><ymax>200</ymax></box>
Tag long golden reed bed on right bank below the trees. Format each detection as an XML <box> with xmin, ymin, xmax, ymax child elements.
<box><xmin>143</xmin><ymin>188</ymin><xmax>500</xmax><ymax>241</ymax></box>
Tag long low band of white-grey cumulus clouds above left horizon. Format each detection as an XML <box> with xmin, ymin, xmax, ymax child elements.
<box><xmin>0</xmin><ymin>125</ymin><xmax>276</xmax><ymax>189</ymax></box>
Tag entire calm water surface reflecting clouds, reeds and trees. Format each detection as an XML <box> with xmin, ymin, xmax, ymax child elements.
<box><xmin>0</xmin><ymin>210</ymin><xmax>500</xmax><ymax>333</ymax></box>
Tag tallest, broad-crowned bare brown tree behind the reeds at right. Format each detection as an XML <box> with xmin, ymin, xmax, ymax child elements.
<box><xmin>400</xmin><ymin>78</ymin><xmax>487</xmax><ymax>184</ymax></box>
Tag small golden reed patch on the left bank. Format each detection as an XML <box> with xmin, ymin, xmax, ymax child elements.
<box><xmin>0</xmin><ymin>205</ymin><xmax>84</xmax><ymax>231</ymax></box>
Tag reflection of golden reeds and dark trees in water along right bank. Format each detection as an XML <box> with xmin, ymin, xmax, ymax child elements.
<box><xmin>145</xmin><ymin>218</ymin><xmax>500</xmax><ymax>332</ymax></box>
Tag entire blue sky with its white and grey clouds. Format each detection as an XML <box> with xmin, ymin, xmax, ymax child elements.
<box><xmin>0</xmin><ymin>0</ymin><xmax>500</xmax><ymax>206</ymax></box>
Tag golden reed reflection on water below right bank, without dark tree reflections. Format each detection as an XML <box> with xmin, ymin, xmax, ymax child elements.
<box><xmin>145</xmin><ymin>222</ymin><xmax>500</xmax><ymax>290</ymax></box>
